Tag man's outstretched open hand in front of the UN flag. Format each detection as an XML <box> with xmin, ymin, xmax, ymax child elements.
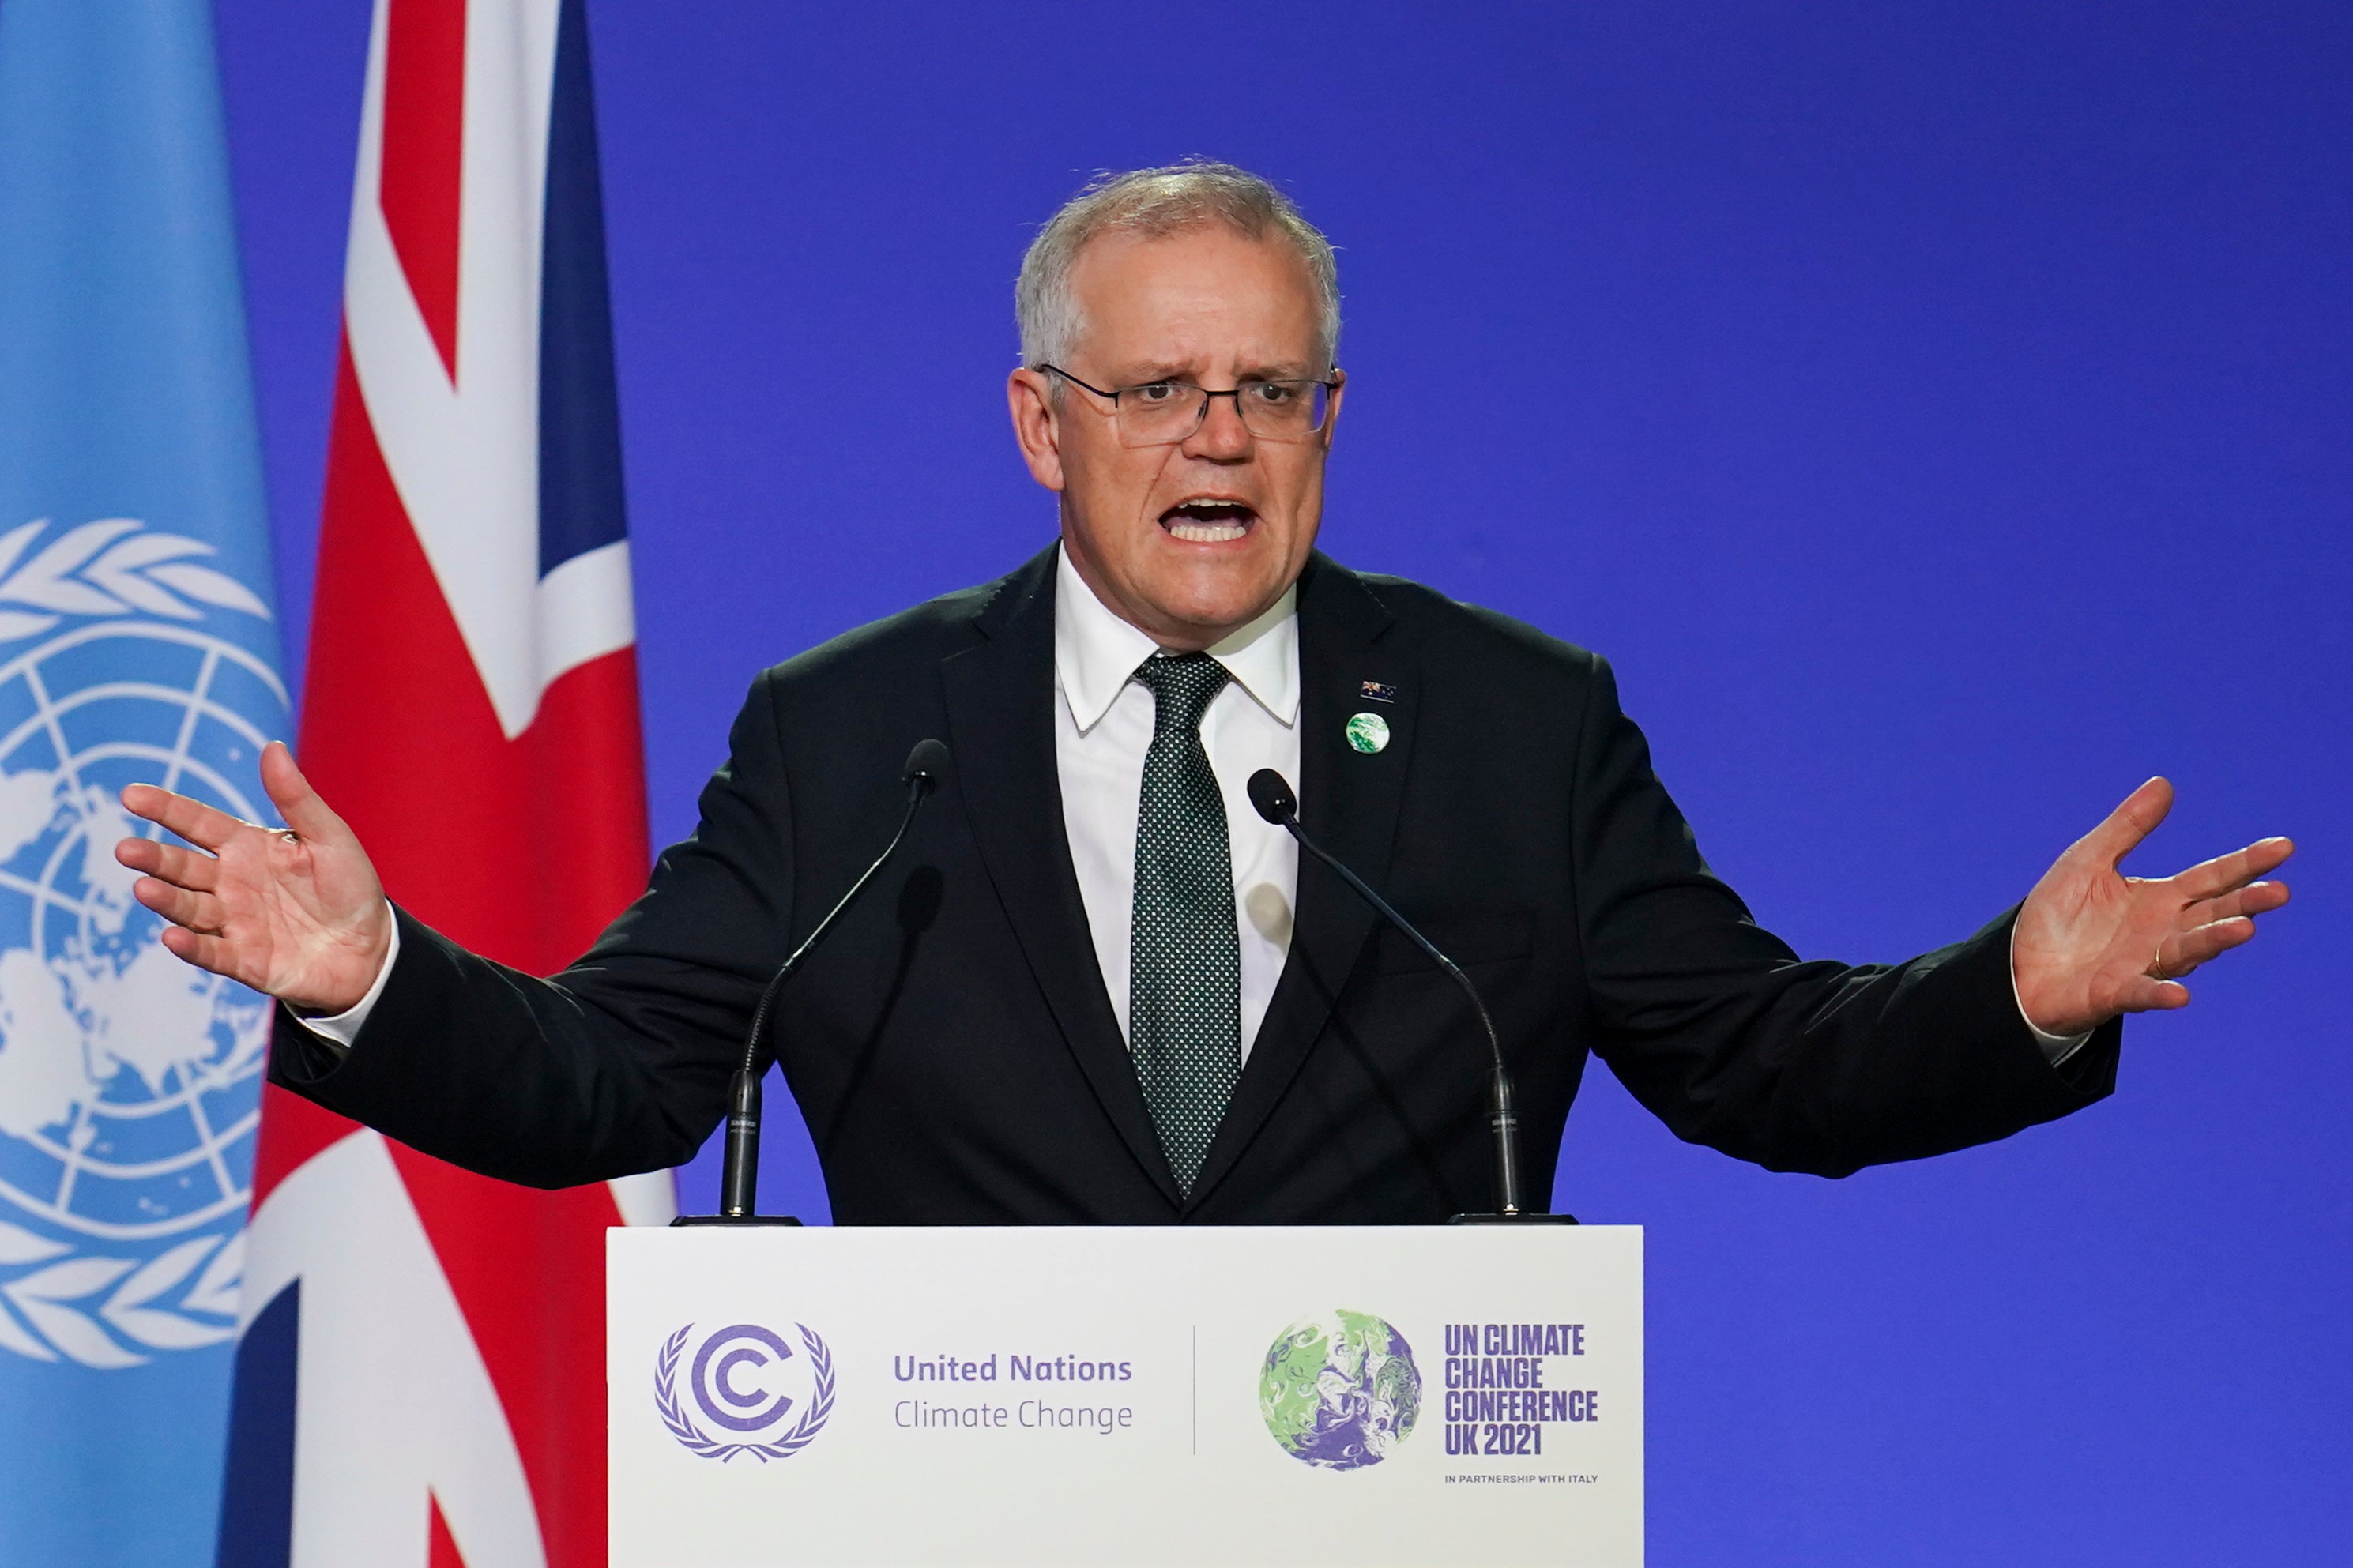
<box><xmin>115</xmin><ymin>740</ymin><xmax>393</xmax><ymax>1016</ymax></box>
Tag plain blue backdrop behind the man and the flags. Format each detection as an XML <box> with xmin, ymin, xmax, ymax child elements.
<box><xmin>219</xmin><ymin>0</ymin><xmax>2353</xmax><ymax>1566</ymax></box>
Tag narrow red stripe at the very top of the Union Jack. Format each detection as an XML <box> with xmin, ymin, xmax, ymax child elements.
<box><xmin>376</xmin><ymin>0</ymin><xmax>466</xmax><ymax>381</ymax></box>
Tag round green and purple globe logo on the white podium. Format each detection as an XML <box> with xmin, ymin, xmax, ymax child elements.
<box><xmin>1259</xmin><ymin>1310</ymin><xmax>1421</xmax><ymax>1469</ymax></box>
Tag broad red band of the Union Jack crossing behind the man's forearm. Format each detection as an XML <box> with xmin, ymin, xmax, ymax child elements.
<box><xmin>301</xmin><ymin>348</ymin><xmax>647</xmax><ymax>1568</ymax></box>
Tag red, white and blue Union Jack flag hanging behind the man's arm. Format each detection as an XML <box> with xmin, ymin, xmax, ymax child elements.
<box><xmin>221</xmin><ymin>0</ymin><xmax>673</xmax><ymax>1568</ymax></box>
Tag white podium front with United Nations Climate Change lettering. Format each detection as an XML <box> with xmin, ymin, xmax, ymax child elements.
<box><xmin>607</xmin><ymin>1225</ymin><xmax>1643</xmax><ymax>1568</ymax></box>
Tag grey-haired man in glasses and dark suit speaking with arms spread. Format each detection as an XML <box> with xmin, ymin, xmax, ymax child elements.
<box><xmin>118</xmin><ymin>164</ymin><xmax>2290</xmax><ymax>1225</ymax></box>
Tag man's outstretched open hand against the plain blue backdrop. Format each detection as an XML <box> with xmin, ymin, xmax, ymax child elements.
<box><xmin>2009</xmin><ymin>778</ymin><xmax>2297</xmax><ymax>1034</ymax></box>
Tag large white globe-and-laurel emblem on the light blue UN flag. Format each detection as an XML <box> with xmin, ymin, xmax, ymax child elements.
<box><xmin>0</xmin><ymin>517</ymin><xmax>287</xmax><ymax>1368</ymax></box>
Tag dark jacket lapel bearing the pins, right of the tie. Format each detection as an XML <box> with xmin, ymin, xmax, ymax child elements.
<box><xmin>1185</xmin><ymin>552</ymin><xmax>1421</xmax><ymax>1209</ymax></box>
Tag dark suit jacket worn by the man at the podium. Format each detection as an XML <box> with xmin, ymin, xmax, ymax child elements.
<box><xmin>273</xmin><ymin>550</ymin><xmax>2120</xmax><ymax>1225</ymax></box>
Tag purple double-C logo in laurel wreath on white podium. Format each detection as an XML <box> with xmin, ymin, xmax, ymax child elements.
<box><xmin>654</xmin><ymin>1323</ymin><xmax>833</xmax><ymax>1465</ymax></box>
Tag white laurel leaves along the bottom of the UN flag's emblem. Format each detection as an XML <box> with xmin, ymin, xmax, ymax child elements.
<box><xmin>0</xmin><ymin>1220</ymin><xmax>245</xmax><ymax>1371</ymax></box>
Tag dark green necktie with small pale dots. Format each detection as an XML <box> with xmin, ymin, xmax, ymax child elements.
<box><xmin>1127</xmin><ymin>653</ymin><xmax>1242</xmax><ymax>1194</ymax></box>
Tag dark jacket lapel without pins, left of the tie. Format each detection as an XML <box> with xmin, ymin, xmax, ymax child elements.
<box><xmin>941</xmin><ymin>547</ymin><xmax>1176</xmax><ymax>1206</ymax></box>
